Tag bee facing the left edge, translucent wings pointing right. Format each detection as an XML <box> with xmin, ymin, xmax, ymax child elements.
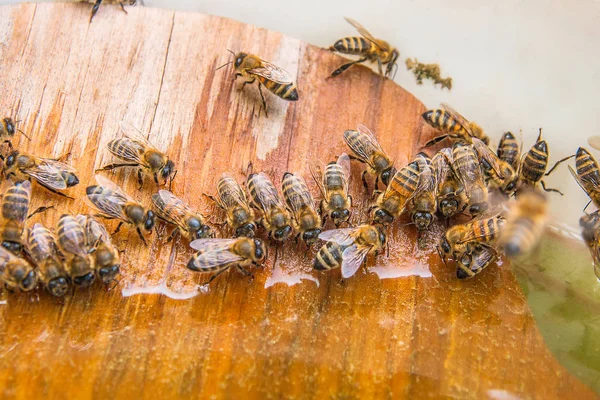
<box><xmin>3</xmin><ymin>150</ymin><xmax>79</xmax><ymax>199</ymax></box>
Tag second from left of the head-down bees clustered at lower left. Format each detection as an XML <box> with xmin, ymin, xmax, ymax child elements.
<box><xmin>26</xmin><ymin>223</ymin><xmax>71</xmax><ymax>297</ymax></box>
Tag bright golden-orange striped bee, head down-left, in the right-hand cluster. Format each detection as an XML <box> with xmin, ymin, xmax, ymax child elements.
<box><xmin>371</xmin><ymin>161</ymin><xmax>419</xmax><ymax>225</ymax></box>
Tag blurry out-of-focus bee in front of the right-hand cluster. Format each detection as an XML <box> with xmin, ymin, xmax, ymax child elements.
<box><xmin>499</xmin><ymin>189</ymin><xmax>548</xmax><ymax>257</ymax></box>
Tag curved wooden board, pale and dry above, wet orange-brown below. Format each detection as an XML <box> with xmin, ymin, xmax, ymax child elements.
<box><xmin>0</xmin><ymin>4</ymin><xmax>595</xmax><ymax>399</ymax></box>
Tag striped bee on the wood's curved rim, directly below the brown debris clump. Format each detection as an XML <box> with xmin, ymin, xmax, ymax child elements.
<box><xmin>422</xmin><ymin>103</ymin><xmax>490</xmax><ymax>147</ymax></box>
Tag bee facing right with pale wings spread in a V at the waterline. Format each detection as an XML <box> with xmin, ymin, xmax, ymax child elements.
<box><xmin>313</xmin><ymin>225</ymin><xmax>386</xmax><ymax>279</ymax></box>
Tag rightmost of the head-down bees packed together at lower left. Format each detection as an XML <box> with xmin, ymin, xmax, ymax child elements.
<box><xmin>75</xmin><ymin>214</ymin><xmax>121</xmax><ymax>285</ymax></box>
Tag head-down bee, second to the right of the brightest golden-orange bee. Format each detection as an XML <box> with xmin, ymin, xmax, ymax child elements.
<box><xmin>431</xmin><ymin>147</ymin><xmax>467</xmax><ymax>218</ymax></box>
